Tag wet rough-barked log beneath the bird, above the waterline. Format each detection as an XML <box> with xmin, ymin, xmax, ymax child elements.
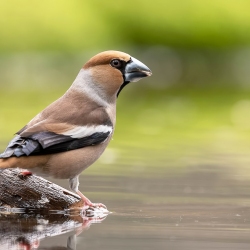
<box><xmin>0</xmin><ymin>169</ymin><xmax>83</xmax><ymax>210</ymax></box>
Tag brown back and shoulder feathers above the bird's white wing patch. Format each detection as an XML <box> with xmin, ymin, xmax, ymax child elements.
<box><xmin>17</xmin><ymin>89</ymin><xmax>115</xmax><ymax>137</ymax></box>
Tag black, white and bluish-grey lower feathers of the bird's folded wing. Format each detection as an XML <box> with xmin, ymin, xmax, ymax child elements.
<box><xmin>0</xmin><ymin>125</ymin><xmax>113</xmax><ymax>158</ymax></box>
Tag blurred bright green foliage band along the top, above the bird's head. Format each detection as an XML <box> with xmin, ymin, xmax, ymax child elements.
<box><xmin>0</xmin><ymin>0</ymin><xmax>250</xmax><ymax>53</ymax></box>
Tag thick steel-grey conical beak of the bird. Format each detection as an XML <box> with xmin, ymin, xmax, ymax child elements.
<box><xmin>125</xmin><ymin>57</ymin><xmax>152</xmax><ymax>82</ymax></box>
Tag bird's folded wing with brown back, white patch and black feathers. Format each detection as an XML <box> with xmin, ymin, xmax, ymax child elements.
<box><xmin>0</xmin><ymin>93</ymin><xmax>113</xmax><ymax>158</ymax></box>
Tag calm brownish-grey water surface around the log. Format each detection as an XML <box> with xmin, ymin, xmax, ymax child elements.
<box><xmin>0</xmin><ymin>166</ymin><xmax>250</xmax><ymax>250</ymax></box>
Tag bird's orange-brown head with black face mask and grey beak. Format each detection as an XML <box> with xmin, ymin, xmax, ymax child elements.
<box><xmin>83</xmin><ymin>51</ymin><xmax>152</xmax><ymax>96</ymax></box>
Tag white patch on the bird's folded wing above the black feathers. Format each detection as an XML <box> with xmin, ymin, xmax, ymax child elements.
<box><xmin>62</xmin><ymin>125</ymin><xmax>113</xmax><ymax>139</ymax></box>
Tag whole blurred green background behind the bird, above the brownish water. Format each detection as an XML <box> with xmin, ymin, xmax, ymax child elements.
<box><xmin>0</xmin><ymin>0</ymin><xmax>250</xmax><ymax>178</ymax></box>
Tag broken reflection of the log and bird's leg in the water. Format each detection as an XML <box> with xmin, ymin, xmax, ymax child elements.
<box><xmin>0</xmin><ymin>208</ymin><xmax>108</xmax><ymax>250</ymax></box>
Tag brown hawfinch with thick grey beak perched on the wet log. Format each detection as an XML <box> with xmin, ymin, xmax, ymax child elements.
<box><xmin>0</xmin><ymin>50</ymin><xmax>152</xmax><ymax>207</ymax></box>
